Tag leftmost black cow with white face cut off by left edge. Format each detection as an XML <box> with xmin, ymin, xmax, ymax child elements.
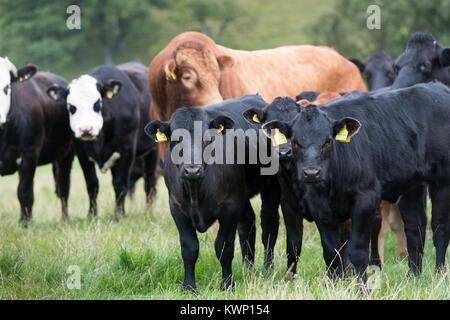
<box><xmin>0</xmin><ymin>58</ymin><xmax>74</xmax><ymax>226</ymax></box>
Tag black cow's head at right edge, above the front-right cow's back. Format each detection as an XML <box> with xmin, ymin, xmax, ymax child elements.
<box><xmin>392</xmin><ymin>32</ymin><xmax>450</xmax><ymax>88</ymax></box>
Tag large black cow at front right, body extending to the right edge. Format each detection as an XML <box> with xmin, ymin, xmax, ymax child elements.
<box><xmin>263</xmin><ymin>83</ymin><xmax>450</xmax><ymax>281</ymax></box>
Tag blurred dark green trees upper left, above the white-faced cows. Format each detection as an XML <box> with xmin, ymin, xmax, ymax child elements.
<box><xmin>0</xmin><ymin>0</ymin><xmax>172</xmax><ymax>71</ymax></box>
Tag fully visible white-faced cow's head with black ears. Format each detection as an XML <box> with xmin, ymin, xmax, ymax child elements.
<box><xmin>47</xmin><ymin>74</ymin><xmax>122</xmax><ymax>141</ymax></box>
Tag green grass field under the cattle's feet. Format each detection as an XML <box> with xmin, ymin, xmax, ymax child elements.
<box><xmin>0</xmin><ymin>164</ymin><xmax>450</xmax><ymax>300</ymax></box>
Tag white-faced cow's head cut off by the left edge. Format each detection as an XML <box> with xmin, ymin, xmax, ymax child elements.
<box><xmin>0</xmin><ymin>57</ymin><xmax>37</xmax><ymax>125</ymax></box>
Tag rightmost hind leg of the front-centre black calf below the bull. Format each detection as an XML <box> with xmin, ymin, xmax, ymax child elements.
<box><xmin>261</xmin><ymin>179</ymin><xmax>281</xmax><ymax>268</ymax></box>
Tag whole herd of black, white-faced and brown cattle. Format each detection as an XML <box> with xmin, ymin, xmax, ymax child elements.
<box><xmin>0</xmin><ymin>32</ymin><xmax>450</xmax><ymax>291</ymax></box>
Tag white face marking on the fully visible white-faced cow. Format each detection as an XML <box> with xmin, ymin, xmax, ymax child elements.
<box><xmin>67</xmin><ymin>75</ymin><xmax>103</xmax><ymax>138</ymax></box>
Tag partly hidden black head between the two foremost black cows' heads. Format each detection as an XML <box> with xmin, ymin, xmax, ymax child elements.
<box><xmin>243</xmin><ymin>97</ymin><xmax>301</xmax><ymax>161</ymax></box>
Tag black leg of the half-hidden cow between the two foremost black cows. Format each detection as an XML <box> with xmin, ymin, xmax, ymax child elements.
<box><xmin>281</xmin><ymin>199</ymin><xmax>303</xmax><ymax>274</ymax></box>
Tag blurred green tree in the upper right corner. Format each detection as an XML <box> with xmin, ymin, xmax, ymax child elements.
<box><xmin>308</xmin><ymin>0</ymin><xmax>450</xmax><ymax>59</ymax></box>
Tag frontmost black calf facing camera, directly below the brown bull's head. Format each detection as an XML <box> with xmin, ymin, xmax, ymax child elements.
<box><xmin>145</xmin><ymin>95</ymin><xmax>280</xmax><ymax>290</ymax></box>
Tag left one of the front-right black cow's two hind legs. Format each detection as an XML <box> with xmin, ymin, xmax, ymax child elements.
<box><xmin>398</xmin><ymin>186</ymin><xmax>427</xmax><ymax>275</ymax></box>
